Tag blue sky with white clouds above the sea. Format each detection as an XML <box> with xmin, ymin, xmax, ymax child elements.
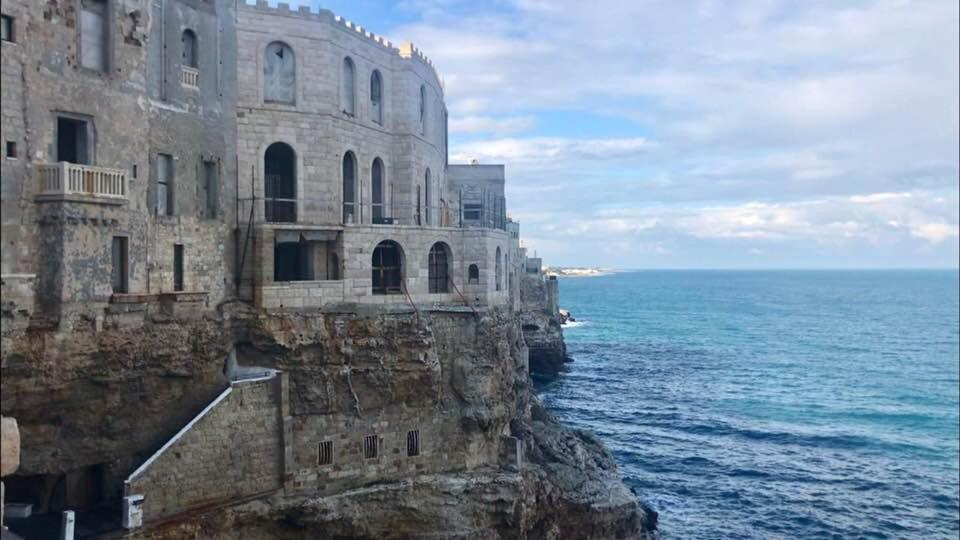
<box><xmin>266</xmin><ymin>0</ymin><xmax>960</xmax><ymax>268</ymax></box>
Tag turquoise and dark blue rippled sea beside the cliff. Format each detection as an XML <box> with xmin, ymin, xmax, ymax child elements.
<box><xmin>538</xmin><ymin>271</ymin><xmax>960</xmax><ymax>539</ymax></box>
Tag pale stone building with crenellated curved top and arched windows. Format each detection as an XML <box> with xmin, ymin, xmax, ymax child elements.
<box><xmin>237</xmin><ymin>2</ymin><xmax>509</xmax><ymax>308</ymax></box>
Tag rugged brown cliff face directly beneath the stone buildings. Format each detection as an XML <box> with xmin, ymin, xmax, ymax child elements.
<box><xmin>2</xmin><ymin>309</ymin><xmax>656</xmax><ymax>539</ymax></box>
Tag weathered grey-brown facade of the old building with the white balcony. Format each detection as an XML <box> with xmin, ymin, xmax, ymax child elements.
<box><xmin>0</xmin><ymin>0</ymin><xmax>236</xmax><ymax>326</ymax></box>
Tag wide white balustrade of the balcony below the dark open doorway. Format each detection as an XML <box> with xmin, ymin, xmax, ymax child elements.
<box><xmin>36</xmin><ymin>161</ymin><xmax>127</xmax><ymax>200</ymax></box>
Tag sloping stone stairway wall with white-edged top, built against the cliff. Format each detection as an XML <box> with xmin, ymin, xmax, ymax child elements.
<box><xmin>124</xmin><ymin>376</ymin><xmax>283</xmax><ymax>521</ymax></box>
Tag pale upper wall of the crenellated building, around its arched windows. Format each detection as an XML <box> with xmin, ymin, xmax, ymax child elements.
<box><xmin>237</xmin><ymin>4</ymin><xmax>450</xmax><ymax>225</ymax></box>
